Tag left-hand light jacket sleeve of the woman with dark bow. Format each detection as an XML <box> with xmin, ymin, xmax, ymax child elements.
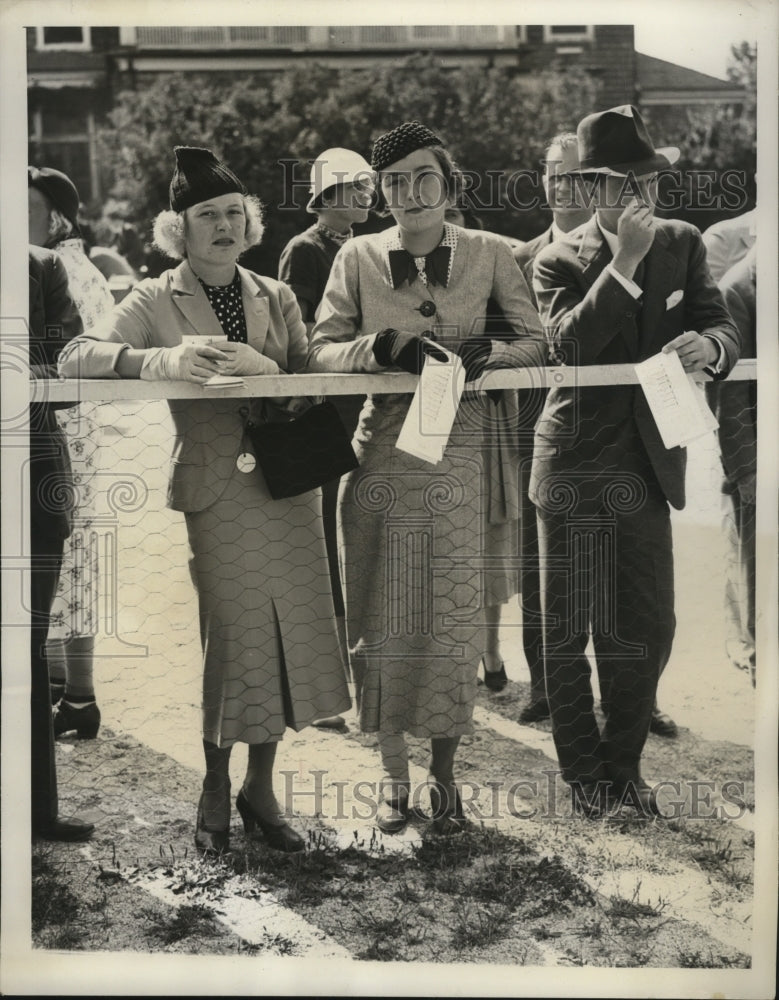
<box><xmin>307</xmin><ymin>243</ymin><xmax>383</xmax><ymax>372</ymax></box>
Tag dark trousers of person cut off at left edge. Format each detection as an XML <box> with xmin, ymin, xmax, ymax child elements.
<box><xmin>30</xmin><ymin>524</ymin><xmax>64</xmax><ymax>830</ymax></box>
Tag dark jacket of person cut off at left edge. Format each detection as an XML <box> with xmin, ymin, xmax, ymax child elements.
<box><xmin>29</xmin><ymin>246</ymin><xmax>82</xmax><ymax>538</ymax></box>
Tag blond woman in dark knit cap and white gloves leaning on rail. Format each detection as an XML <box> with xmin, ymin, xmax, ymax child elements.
<box><xmin>60</xmin><ymin>146</ymin><xmax>349</xmax><ymax>853</ymax></box>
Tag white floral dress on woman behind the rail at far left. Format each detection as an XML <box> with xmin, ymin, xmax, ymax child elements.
<box><xmin>49</xmin><ymin>239</ymin><xmax>114</xmax><ymax>641</ymax></box>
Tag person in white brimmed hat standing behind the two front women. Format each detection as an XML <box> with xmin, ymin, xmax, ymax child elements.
<box><xmin>279</xmin><ymin>146</ymin><xmax>374</xmax><ymax>729</ymax></box>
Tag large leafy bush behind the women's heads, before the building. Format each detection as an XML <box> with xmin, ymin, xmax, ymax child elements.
<box><xmin>94</xmin><ymin>54</ymin><xmax>597</xmax><ymax>274</ymax></box>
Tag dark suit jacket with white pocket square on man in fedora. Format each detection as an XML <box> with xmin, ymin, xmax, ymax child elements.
<box><xmin>530</xmin><ymin>218</ymin><xmax>739</xmax><ymax>509</ymax></box>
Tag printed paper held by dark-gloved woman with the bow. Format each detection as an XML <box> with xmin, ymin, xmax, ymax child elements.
<box><xmin>396</xmin><ymin>344</ymin><xmax>465</xmax><ymax>465</ymax></box>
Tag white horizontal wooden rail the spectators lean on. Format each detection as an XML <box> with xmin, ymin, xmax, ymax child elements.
<box><xmin>30</xmin><ymin>358</ymin><xmax>757</xmax><ymax>403</ymax></box>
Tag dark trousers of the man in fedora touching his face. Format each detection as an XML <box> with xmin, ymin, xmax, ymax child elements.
<box><xmin>538</xmin><ymin>484</ymin><xmax>676</xmax><ymax>788</ymax></box>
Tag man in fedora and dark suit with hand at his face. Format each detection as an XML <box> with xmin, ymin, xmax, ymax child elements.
<box><xmin>530</xmin><ymin>105</ymin><xmax>738</xmax><ymax>815</ymax></box>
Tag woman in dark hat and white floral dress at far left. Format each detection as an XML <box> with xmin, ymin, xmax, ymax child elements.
<box><xmin>27</xmin><ymin>166</ymin><xmax>114</xmax><ymax>739</ymax></box>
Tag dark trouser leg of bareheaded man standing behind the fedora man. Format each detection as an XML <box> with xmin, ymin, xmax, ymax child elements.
<box><xmin>519</xmin><ymin>443</ymin><xmax>546</xmax><ymax>704</ymax></box>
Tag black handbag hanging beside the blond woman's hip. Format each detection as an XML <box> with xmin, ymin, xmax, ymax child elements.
<box><xmin>245</xmin><ymin>401</ymin><xmax>360</xmax><ymax>500</ymax></box>
